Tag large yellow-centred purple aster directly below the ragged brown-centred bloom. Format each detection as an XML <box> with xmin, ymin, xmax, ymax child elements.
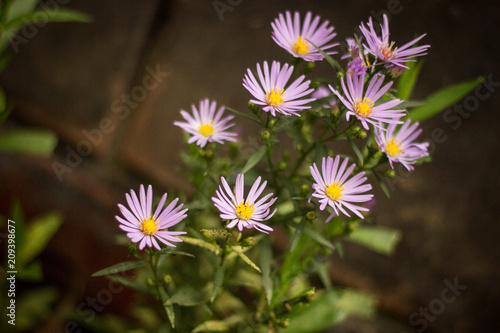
<box><xmin>330</xmin><ymin>74</ymin><xmax>405</xmax><ymax>130</ymax></box>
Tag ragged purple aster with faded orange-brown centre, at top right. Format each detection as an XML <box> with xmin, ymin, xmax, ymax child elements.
<box><xmin>359</xmin><ymin>14</ymin><xmax>430</xmax><ymax>68</ymax></box>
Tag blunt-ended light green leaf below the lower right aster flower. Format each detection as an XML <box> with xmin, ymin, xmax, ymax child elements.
<box><xmin>347</xmin><ymin>226</ymin><xmax>401</xmax><ymax>255</ymax></box>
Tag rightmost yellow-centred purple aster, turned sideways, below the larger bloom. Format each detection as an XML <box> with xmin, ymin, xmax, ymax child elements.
<box><xmin>375</xmin><ymin>119</ymin><xmax>429</xmax><ymax>171</ymax></box>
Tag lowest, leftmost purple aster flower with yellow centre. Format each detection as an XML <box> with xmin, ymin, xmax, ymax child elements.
<box><xmin>115</xmin><ymin>185</ymin><xmax>187</xmax><ymax>250</ymax></box>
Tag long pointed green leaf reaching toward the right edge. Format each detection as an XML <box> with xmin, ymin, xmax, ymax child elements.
<box><xmin>408</xmin><ymin>77</ymin><xmax>483</xmax><ymax>121</ymax></box>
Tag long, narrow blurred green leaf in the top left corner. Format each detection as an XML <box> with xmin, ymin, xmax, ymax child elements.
<box><xmin>5</xmin><ymin>8</ymin><xmax>92</xmax><ymax>29</ymax></box>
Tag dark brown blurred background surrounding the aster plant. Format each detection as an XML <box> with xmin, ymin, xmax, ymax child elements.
<box><xmin>0</xmin><ymin>0</ymin><xmax>500</xmax><ymax>333</ymax></box>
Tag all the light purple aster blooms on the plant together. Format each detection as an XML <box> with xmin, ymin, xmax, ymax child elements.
<box><xmin>116</xmin><ymin>12</ymin><xmax>429</xmax><ymax>249</ymax></box>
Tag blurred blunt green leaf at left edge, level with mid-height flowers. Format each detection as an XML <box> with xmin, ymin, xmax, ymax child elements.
<box><xmin>0</xmin><ymin>130</ymin><xmax>57</xmax><ymax>157</ymax></box>
